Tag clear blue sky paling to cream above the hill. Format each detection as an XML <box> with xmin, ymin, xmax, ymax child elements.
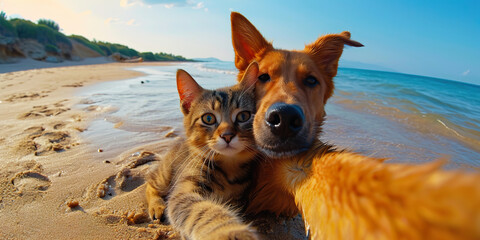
<box><xmin>0</xmin><ymin>0</ymin><xmax>480</xmax><ymax>85</ymax></box>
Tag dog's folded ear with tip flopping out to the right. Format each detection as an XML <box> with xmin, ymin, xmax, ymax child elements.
<box><xmin>304</xmin><ymin>31</ymin><xmax>363</xmax><ymax>78</ymax></box>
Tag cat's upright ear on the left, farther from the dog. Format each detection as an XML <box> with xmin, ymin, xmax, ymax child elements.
<box><xmin>177</xmin><ymin>69</ymin><xmax>203</xmax><ymax>114</ymax></box>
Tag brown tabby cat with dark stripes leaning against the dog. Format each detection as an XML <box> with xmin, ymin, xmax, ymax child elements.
<box><xmin>146</xmin><ymin>62</ymin><xmax>258</xmax><ymax>240</ymax></box>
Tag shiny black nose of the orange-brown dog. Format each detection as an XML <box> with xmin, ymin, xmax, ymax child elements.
<box><xmin>265</xmin><ymin>102</ymin><xmax>305</xmax><ymax>138</ymax></box>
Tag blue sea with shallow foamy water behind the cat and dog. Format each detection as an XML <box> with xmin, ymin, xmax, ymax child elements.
<box><xmin>77</xmin><ymin>61</ymin><xmax>480</xmax><ymax>169</ymax></box>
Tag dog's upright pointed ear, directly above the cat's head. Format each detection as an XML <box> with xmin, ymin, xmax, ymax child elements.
<box><xmin>230</xmin><ymin>12</ymin><xmax>273</xmax><ymax>71</ymax></box>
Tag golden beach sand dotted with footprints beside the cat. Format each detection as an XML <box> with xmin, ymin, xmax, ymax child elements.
<box><xmin>0</xmin><ymin>60</ymin><xmax>304</xmax><ymax>239</ymax></box>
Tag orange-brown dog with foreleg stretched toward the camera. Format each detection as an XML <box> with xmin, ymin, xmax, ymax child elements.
<box><xmin>231</xmin><ymin>12</ymin><xmax>480</xmax><ymax>239</ymax></box>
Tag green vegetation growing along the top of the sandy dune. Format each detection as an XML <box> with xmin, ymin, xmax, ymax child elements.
<box><xmin>0</xmin><ymin>11</ymin><xmax>191</xmax><ymax>61</ymax></box>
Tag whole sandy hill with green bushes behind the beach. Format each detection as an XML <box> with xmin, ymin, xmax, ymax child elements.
<box><xmin>0</xmin><ymin>11</ymin><xmax>192</xmax><ymax>63</ymax></box>
